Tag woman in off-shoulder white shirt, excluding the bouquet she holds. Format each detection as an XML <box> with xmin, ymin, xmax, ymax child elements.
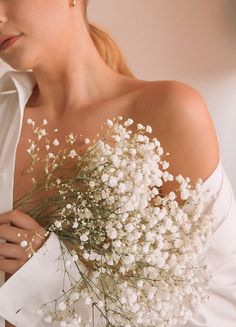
<box><xmin>0</xmin><ymin>0</ymin><xmax>236</xmax><ymax>327</ymax></box>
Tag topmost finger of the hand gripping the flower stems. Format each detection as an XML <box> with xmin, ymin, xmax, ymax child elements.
<box><xmin>0</xmin><ymin>210</ymin><xmax>39</xmax><ymax>230</ymax></box>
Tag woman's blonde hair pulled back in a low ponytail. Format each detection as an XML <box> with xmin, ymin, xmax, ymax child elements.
<box><xmin>81</xmin><ymin>0</ymin><xmax>135</xmax><ymax>77</ymax></box>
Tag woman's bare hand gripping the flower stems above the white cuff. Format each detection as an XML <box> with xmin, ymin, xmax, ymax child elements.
<box><xmin>0</xmin><ymin>210</ymin><xmax>47</xmax><ymax>277</ymax></box>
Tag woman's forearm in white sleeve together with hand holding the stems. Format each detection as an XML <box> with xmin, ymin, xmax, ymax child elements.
<box><xmin>0</xmin><ymin>210</ymin><xmax>87</xmax><ymax>327</ymax></box>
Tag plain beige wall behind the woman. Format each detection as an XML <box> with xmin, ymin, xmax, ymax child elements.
<box><xmin>0</xmin><ymin>0</ymin><xmax>236</xmax><ymax>192</ymax></box>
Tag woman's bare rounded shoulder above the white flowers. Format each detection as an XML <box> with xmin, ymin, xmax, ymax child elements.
<box><xmin>132</xmin><ymin>81</ymin><xmax>220</xmax><ymax>202</ymax></box>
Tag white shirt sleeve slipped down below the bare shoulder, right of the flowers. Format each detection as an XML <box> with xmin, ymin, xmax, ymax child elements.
<box><xmin>175</xmin><ymin>166</ymin><xmax>236</xmax><ymax>327</ymax></box>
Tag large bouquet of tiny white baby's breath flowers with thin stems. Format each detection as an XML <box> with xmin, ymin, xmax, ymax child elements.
<box><xmin>15</xmin><ymin>116</ymin><xmax>213</xmax><ymax>327</ymax></box>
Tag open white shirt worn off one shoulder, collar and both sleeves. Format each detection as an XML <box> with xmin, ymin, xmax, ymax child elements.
<box><xmin>0</xmin><ymin>71</ymin><xmax>236</xmax><ymax>327</ymax></box>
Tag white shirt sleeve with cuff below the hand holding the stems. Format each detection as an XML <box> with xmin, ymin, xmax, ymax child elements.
<box><xmin>0</xmin><ymin>232</ymin><xmax>91</xmax><ymax>327</ymax></box>
